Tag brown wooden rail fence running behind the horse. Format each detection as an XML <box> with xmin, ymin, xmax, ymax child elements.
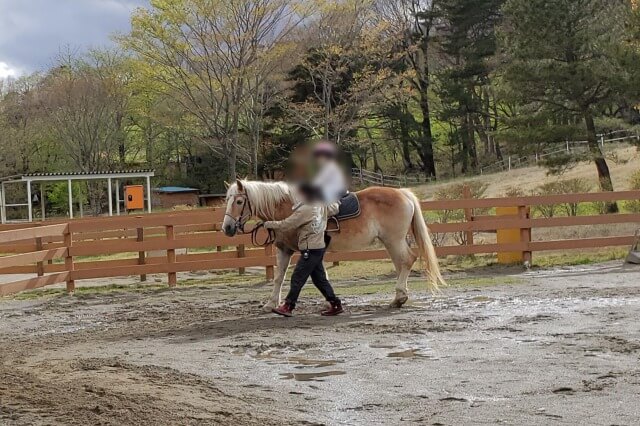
<box><xmin>0</xmin><ymin>191</ymin><xmax>640</xmax><ymax>296</ymax></box>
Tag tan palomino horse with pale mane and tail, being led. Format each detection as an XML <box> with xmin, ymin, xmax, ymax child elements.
<box><xmin>222</xmin><ymin>180</ymin><xmax>444</xmax><ymax>311</ymax></box>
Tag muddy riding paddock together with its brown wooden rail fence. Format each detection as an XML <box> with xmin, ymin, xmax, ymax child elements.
<box><xmin>0</xmin><ymin>191</ymin><xmax>640</xmax><ymax>425</ymax></box>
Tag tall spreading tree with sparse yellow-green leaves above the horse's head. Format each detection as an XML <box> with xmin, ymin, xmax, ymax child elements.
<box><xmin>121</xmin><ymin>0</ymin><xmax>308</xmax><ymax>179</ymax></box>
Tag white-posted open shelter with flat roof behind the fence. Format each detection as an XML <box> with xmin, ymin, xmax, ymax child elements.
<box><xmin>0</xmin><ymin>170</ymin><xmax>155</xmax><ymax>223</ymax></box>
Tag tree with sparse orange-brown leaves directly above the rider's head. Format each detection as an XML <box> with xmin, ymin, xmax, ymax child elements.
<box><xmin>288</xmin><ymin>0</ymin><xmax>398</xmax><ymax>171</ymax></box>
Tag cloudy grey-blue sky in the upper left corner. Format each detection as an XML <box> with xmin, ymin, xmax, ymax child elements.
<box><xmin>0</xmin><ymin>0</ymin><xmax>149</xmax><ymax>79</ymax></box>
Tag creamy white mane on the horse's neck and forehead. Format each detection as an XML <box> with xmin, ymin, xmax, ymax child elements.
<box><xmin>234</xmin><ymin>180</ymin><xmax>296</xmax><ymax>218</ymax></box>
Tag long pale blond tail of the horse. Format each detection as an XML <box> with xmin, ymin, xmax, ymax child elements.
<box><xmin>401</xmin><ymin>189</ymin><xmax>446</xmax><ymax>290</ymax></box>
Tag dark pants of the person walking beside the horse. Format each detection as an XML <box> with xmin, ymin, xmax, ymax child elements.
<box><xmin>285</xmin><ymin>249</ymin><xmax>340</xmax><ymax>308</ymax></box>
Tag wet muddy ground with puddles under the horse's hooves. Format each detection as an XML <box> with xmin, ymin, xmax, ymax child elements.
<box><xmin>0</xmin><ymin>263</ymin><xmax>640</xmax><ymax>425</ymax></box>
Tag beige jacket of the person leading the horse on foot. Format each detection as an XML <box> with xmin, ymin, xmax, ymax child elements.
<box><xmin>264</xmin><ymin>203</ymin><xmax>340</xmax><ymax>251</ymax></box>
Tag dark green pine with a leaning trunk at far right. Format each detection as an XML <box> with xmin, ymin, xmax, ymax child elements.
<box><xmin>502</xmin><ymin>0</ymin><xmax>631</xmax><ymax>212</ymax></box>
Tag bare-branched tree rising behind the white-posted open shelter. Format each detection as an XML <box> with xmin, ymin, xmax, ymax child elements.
<box><xmin>39</xmin><ymin>52</ymin><xmax>126</xmax><ymax>214</ymax></box>
